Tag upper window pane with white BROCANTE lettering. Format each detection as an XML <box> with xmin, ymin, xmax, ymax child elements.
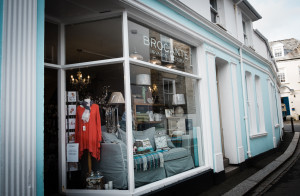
<box><xmin>128</xmin><ymin>21</ymin><xmax>195</xmax><ymax>73</ymax></box>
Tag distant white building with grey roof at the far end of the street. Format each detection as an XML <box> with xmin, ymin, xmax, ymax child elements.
<box><xmin>270</xmin><ymin>38</ymin><xmax>300</xmax><ymax>120</ymax></box>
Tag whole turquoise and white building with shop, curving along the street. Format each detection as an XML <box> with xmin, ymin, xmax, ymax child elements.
<box><xmin>0</xmin><ymin>0</ymin><xmax>283</xmax><ymax>195</ymax></box>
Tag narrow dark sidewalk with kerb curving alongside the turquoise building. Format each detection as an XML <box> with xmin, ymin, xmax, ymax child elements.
<box><xmin>199</xmin><ymin>132</ymin><xmax>300</xmax><ymax>196</ymax></box>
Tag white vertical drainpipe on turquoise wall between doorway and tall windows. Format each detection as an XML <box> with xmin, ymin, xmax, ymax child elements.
<box><xmin>239</xmin><ymin>46</ymin><xmax>251</xmax><ymax>157</ymax></box>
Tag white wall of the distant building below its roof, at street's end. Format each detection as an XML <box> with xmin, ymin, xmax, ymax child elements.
<box><xmin>277</xmin><ymin>59</ymin><xmax>300</xmax><ymax>119</ymax></box>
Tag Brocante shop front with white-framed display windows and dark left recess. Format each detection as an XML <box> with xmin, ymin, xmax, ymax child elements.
<box><xmin>44</xmin><ymin>1</ymin><xmax>211</xmax><ymax>195</ymax></box>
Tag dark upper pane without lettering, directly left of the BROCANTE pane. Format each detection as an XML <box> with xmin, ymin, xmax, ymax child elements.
<box><xmin>65</xmin><ymin>17</ymin><xmax>123</xmax><ymax>64</ymax></box>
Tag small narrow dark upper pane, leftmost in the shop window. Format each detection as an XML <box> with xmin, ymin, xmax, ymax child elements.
<box><xmin>44</xmin><ymin>22</ymin><xmax>58</xmax><ymax>64</ymax></box>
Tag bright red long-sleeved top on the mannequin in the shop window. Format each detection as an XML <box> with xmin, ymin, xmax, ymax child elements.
<box><xmin>75</xmin><ymin>104</ymin><xmax>102</xmax><ymax>161</ymax></box>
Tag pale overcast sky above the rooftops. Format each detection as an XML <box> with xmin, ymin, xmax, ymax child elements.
<box><xmin>248</xmin><ymin>0</ymin><xmax>300</xmax><ymax>41</ymax></box>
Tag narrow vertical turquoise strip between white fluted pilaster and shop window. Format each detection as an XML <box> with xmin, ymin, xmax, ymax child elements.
<box><xmin>36</xmin><ymin>0</ymin><xmax>45</xmax><ymax>196</ymax></box>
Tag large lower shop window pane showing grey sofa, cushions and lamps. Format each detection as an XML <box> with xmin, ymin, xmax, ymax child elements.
<box><xmin>130</xmin><ymin>65</ymin><xmax>203</xmax><ymax>187</ymax></box>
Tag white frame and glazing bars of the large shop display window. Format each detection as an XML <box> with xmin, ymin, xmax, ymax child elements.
<box><xmin>44</xmin><ymin>10</ymin><xmax>212</xmax><ymax>195</ymax></box>
